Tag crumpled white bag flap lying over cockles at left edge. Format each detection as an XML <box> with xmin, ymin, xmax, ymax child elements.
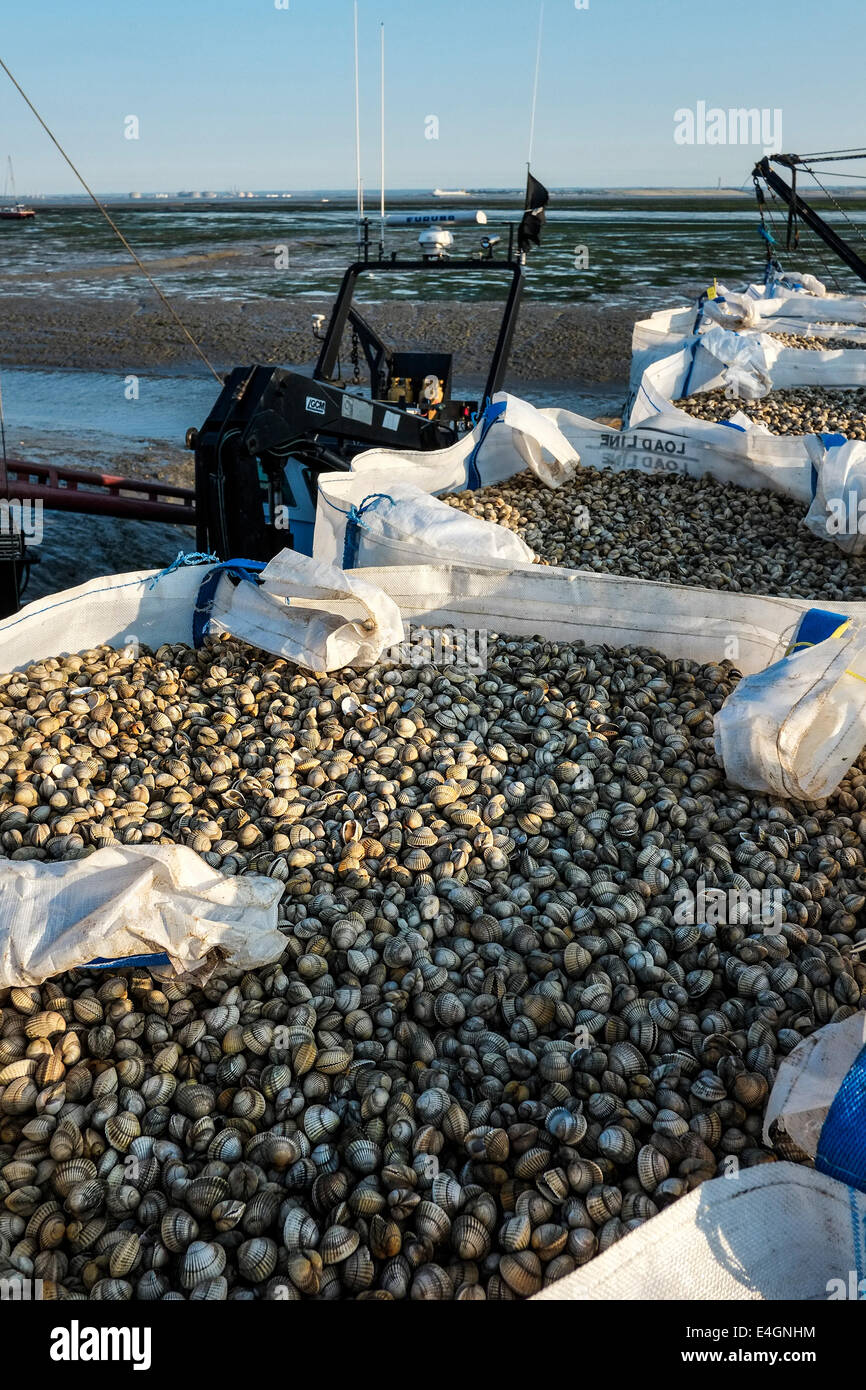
<box><xmin>0</xmin><ymin>845</ymin><xmax>285</xmax><ymax>988</ymax></box>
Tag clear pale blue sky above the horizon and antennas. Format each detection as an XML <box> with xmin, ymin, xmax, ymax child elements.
<box><xmin>0</xmin><ymin>0</ymin><xmax>866</xmax><ymax>193</ymax></box>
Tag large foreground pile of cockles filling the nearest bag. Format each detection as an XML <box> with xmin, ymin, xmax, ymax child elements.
<box><xmin>0</xmin><ymin>637</ymin><xmax>866</xmax><ymax>1300</ymax></box>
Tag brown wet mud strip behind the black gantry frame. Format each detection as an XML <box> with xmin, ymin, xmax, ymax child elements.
<box><xmin>0</xmin><ymin>295</ymin><xmax>644</xmax><ymax>382</ymax></box>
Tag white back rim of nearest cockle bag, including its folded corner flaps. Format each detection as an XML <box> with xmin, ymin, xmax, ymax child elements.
<box><xmin>8</xmin><ymin>555</ymin><xmax>866</xmax><ymax>799</ymax></box>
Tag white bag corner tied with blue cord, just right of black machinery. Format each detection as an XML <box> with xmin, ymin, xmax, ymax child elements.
<box><xmin>313</xmin><ymin>464</ymin><xmax>534</xmax><ymax>570</ymax></box>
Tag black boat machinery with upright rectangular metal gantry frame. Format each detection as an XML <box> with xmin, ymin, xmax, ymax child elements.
<box><xmin>188</xmin><ymin>208</ymin><xmax>525</xmax><ymax>560</ymax></box>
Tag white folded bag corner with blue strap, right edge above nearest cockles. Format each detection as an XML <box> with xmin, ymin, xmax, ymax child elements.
<box><xmin>714</xmin><ymin>609</ymin><xmax>866</xmax><ymax>801</ymax></box>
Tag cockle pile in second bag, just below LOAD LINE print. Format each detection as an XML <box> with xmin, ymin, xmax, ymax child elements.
<box><xmin>441</xmin><ymin>468</ymin><xmax>866</xmax><ymax>602</ymax></box>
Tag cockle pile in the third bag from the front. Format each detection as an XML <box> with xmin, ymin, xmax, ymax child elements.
<box><xmin>674</xmin><ymin>386</ymin><xmax>866</xmax><ymax>439</ymax></box>
